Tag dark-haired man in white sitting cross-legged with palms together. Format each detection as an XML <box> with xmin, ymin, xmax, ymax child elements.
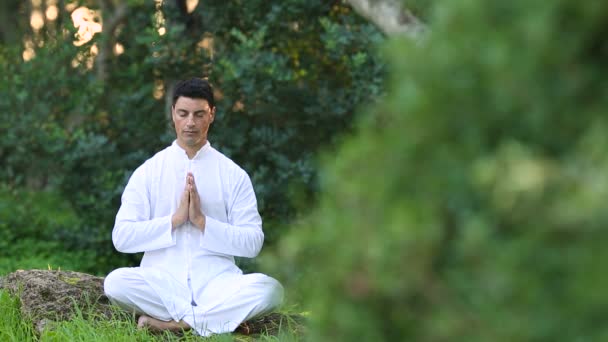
<box><xmin>104</xmin><ymin>78</ymin><xmax>283</xmax><ymax>336</ymax></box>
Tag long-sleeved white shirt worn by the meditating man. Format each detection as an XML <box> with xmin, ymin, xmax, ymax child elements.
<box><xmin>112</xmin><ymin>141</ymin><xmax>264</xmax><ymax>308</ymax></box>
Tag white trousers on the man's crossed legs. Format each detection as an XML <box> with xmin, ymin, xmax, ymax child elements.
<box><xmin>104</xmin><ymin>267</ymin><xmax>283</xmax><ymax>336</ymax></box>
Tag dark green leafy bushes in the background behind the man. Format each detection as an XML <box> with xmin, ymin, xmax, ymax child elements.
<box><xmin>0</xmin><ymin>0</ymin><xmax>383</xmax><ymax>273</ymax></box>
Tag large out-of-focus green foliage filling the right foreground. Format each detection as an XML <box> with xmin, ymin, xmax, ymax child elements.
<box><xmin>277</xmin><ymin>0</ymin><xmax>608</xmax><ymax>341</ymax></box>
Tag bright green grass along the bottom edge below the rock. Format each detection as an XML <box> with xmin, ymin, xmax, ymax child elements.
<box><xmin>0</xmin><ymin>290</ymin><xmax>301</xmax><ymax>342</ymax></box>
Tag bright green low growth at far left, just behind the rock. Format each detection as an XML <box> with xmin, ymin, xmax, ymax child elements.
<box><xmin>0</xmin><ymin>187</ymin><xmax>101</xmax><ymax>274</ymax></box>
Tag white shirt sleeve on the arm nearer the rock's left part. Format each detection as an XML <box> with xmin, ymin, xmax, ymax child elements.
<box><xmin>112</xmin><ymin>165</ymin><xmax>175</xmax><ymax>253</ymax></box>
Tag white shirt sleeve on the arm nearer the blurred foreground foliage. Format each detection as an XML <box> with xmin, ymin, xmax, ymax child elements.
<box><xmin>201</xmin><ymin>170</ymin><xmax>264</xmax><ymax>258</ymax></box>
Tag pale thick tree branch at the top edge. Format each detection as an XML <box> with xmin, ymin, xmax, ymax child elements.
<box><xmin>346</xmin><ymin>0</ymin><xmax>426</xmax><ymax>39</ymax></box>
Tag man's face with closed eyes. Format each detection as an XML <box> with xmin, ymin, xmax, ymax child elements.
<box><xmin>171</xmin><ymin>97</ymin><xmax>215</xmax><ymax>149</ymax></box>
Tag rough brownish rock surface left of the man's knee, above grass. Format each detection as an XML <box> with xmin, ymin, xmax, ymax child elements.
<box><xmin>0</xmin><ymin>270</ymin><xmax>111</xmax><ymax>333</ymax></box>
